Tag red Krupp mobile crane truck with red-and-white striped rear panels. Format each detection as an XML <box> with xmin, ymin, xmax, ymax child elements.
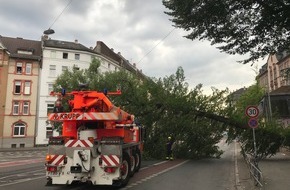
<box><xmin>46</xmin><ymin>91</ymin><xmax>143</xmax><ymax>186</ymax></box>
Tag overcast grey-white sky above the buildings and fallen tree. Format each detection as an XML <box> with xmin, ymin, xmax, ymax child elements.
<box><xmin>0</xmin><ymin>0</ymin><xmax>266</xmax><ymax>93</ymax></box>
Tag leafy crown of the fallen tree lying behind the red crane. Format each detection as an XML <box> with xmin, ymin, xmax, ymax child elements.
<box><xmin>55</xmin><ymin>60</ymin><xmax>227</xmax><ymax>159</ymax></box>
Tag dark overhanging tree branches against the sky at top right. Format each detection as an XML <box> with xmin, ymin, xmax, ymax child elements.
<box><xmin>163</xmin><ymin>0</ymin><xmax>290</xmax><ymax>63</ymax></box>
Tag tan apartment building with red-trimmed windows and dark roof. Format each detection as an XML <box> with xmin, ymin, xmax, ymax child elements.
<box><xmin>0</xmin><ymin>36</ymin><xmax>41</xmax><ymax>148</ymax></box>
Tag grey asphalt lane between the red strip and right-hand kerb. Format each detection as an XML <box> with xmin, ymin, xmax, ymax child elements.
<box><xmin>123</xmin><ymin>140</ymin><xmax>235</xmax><ymax>190</ymax></box>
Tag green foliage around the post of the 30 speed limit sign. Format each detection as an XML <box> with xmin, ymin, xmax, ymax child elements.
<box><xmin>228</xmin><ymin>84</ymin><xmax>289</xmax><ymax>159</ymax></box>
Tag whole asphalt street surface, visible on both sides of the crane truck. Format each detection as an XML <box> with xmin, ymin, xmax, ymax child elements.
<box><xmin>0</xmin><ymin>142</ymin><xmax>242</xmax><ymax>190</ymax></box>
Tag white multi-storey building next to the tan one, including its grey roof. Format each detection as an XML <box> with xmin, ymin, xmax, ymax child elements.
<box><xmin>35</xmin><ymin>38</ymin><xmax>120</xmax><ymax>145</ymax></box>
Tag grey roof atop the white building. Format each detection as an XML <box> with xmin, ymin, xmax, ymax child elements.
<box><xmin>43</xmin><ymin>39</ymin><xmax>96</xmax><ymax>53</ymax></box>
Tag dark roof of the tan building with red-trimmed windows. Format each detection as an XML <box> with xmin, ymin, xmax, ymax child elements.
<box><xmin>0</xmin><ymin>35</ymin><xmax>41</xmax><ymax>60</ymax></box>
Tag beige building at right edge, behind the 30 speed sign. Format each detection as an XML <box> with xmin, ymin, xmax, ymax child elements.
<box><xmin>257</xmin><ymin>51</ymin><xmax>290</xmax><ymax>127</ymax></box>
